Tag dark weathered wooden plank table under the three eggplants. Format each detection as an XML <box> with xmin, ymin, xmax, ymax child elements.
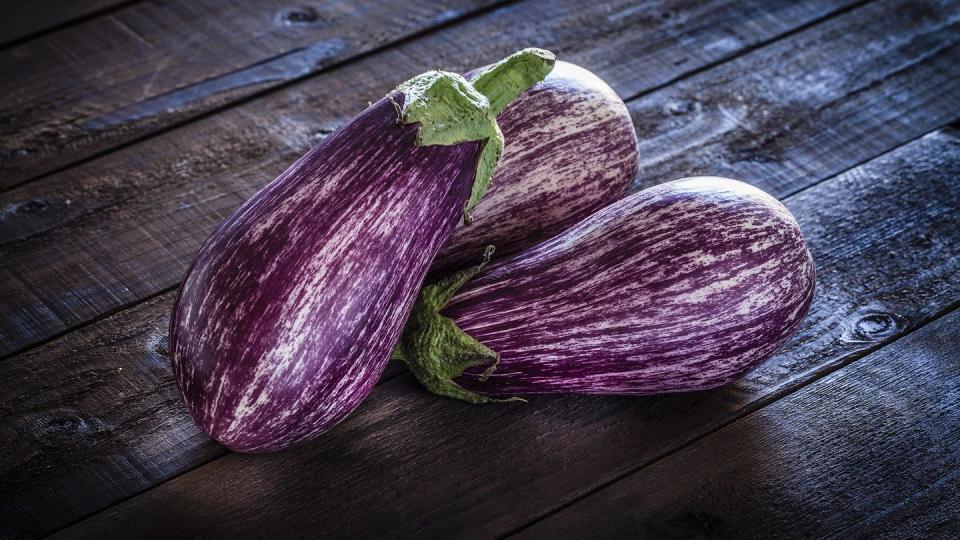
<box><xmin>0</xmin><ymin>0</ymin><xmax>960</xmax><ymax>538</ymax></box>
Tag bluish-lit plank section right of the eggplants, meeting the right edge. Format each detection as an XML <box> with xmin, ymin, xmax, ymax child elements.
<box><xmin>630</xmin><ymin>2</ymin><xmax>960</xmax><ymax>197</ymax></box>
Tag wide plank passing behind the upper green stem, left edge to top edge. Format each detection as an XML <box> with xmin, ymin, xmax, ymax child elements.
<box><xmin>0</xmin><ymin>0</ymin><xmax>864</xmax><ymax>355</ymax></box>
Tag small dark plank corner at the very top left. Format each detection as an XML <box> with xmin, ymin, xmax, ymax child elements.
<box><xmin>0</xmin><ymin>0</ymin><xmax>130</xmax><ymax>46</ymax></box>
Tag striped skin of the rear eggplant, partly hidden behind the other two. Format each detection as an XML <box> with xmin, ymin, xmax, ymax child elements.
<box><xmin>431</xmin><ymin>61</ymin><xmax>639</xmax><ymax>274</ymax></box>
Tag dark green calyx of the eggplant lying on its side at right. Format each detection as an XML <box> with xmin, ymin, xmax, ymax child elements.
<box><xmin>392</xmin><ymin>246</ymin><xmax>523</xmax><ymax>404</ymax></box>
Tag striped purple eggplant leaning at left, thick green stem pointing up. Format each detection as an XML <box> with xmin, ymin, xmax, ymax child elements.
<box><xmin>170</xmin><ymin>49</ymin><xmax>554</xmax><ymax>452</ymax></box>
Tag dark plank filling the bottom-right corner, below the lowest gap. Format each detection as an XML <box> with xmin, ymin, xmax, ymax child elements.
<box><xmin>519</xmin><ymin>311</ymin><xmax>960</xmax><ymax>539</ymax></box>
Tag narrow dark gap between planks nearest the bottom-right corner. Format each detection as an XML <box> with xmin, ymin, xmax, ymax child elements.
<box><xmin>502</xmin><ymin>302</ymin><xmax>960</xmax><ymax>538</ymax></box>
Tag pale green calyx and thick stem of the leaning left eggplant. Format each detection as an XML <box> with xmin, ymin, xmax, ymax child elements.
<box><xmin>397</xmin><ymin>49</ymin><xmax>555</xmax><ymax>219</ymax></box>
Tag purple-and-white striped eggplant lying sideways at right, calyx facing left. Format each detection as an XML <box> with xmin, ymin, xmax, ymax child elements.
<box><xmin>395</xmin><ymin>177</ymin><xmax>814</xmax><ymax>402</ymax></box>
